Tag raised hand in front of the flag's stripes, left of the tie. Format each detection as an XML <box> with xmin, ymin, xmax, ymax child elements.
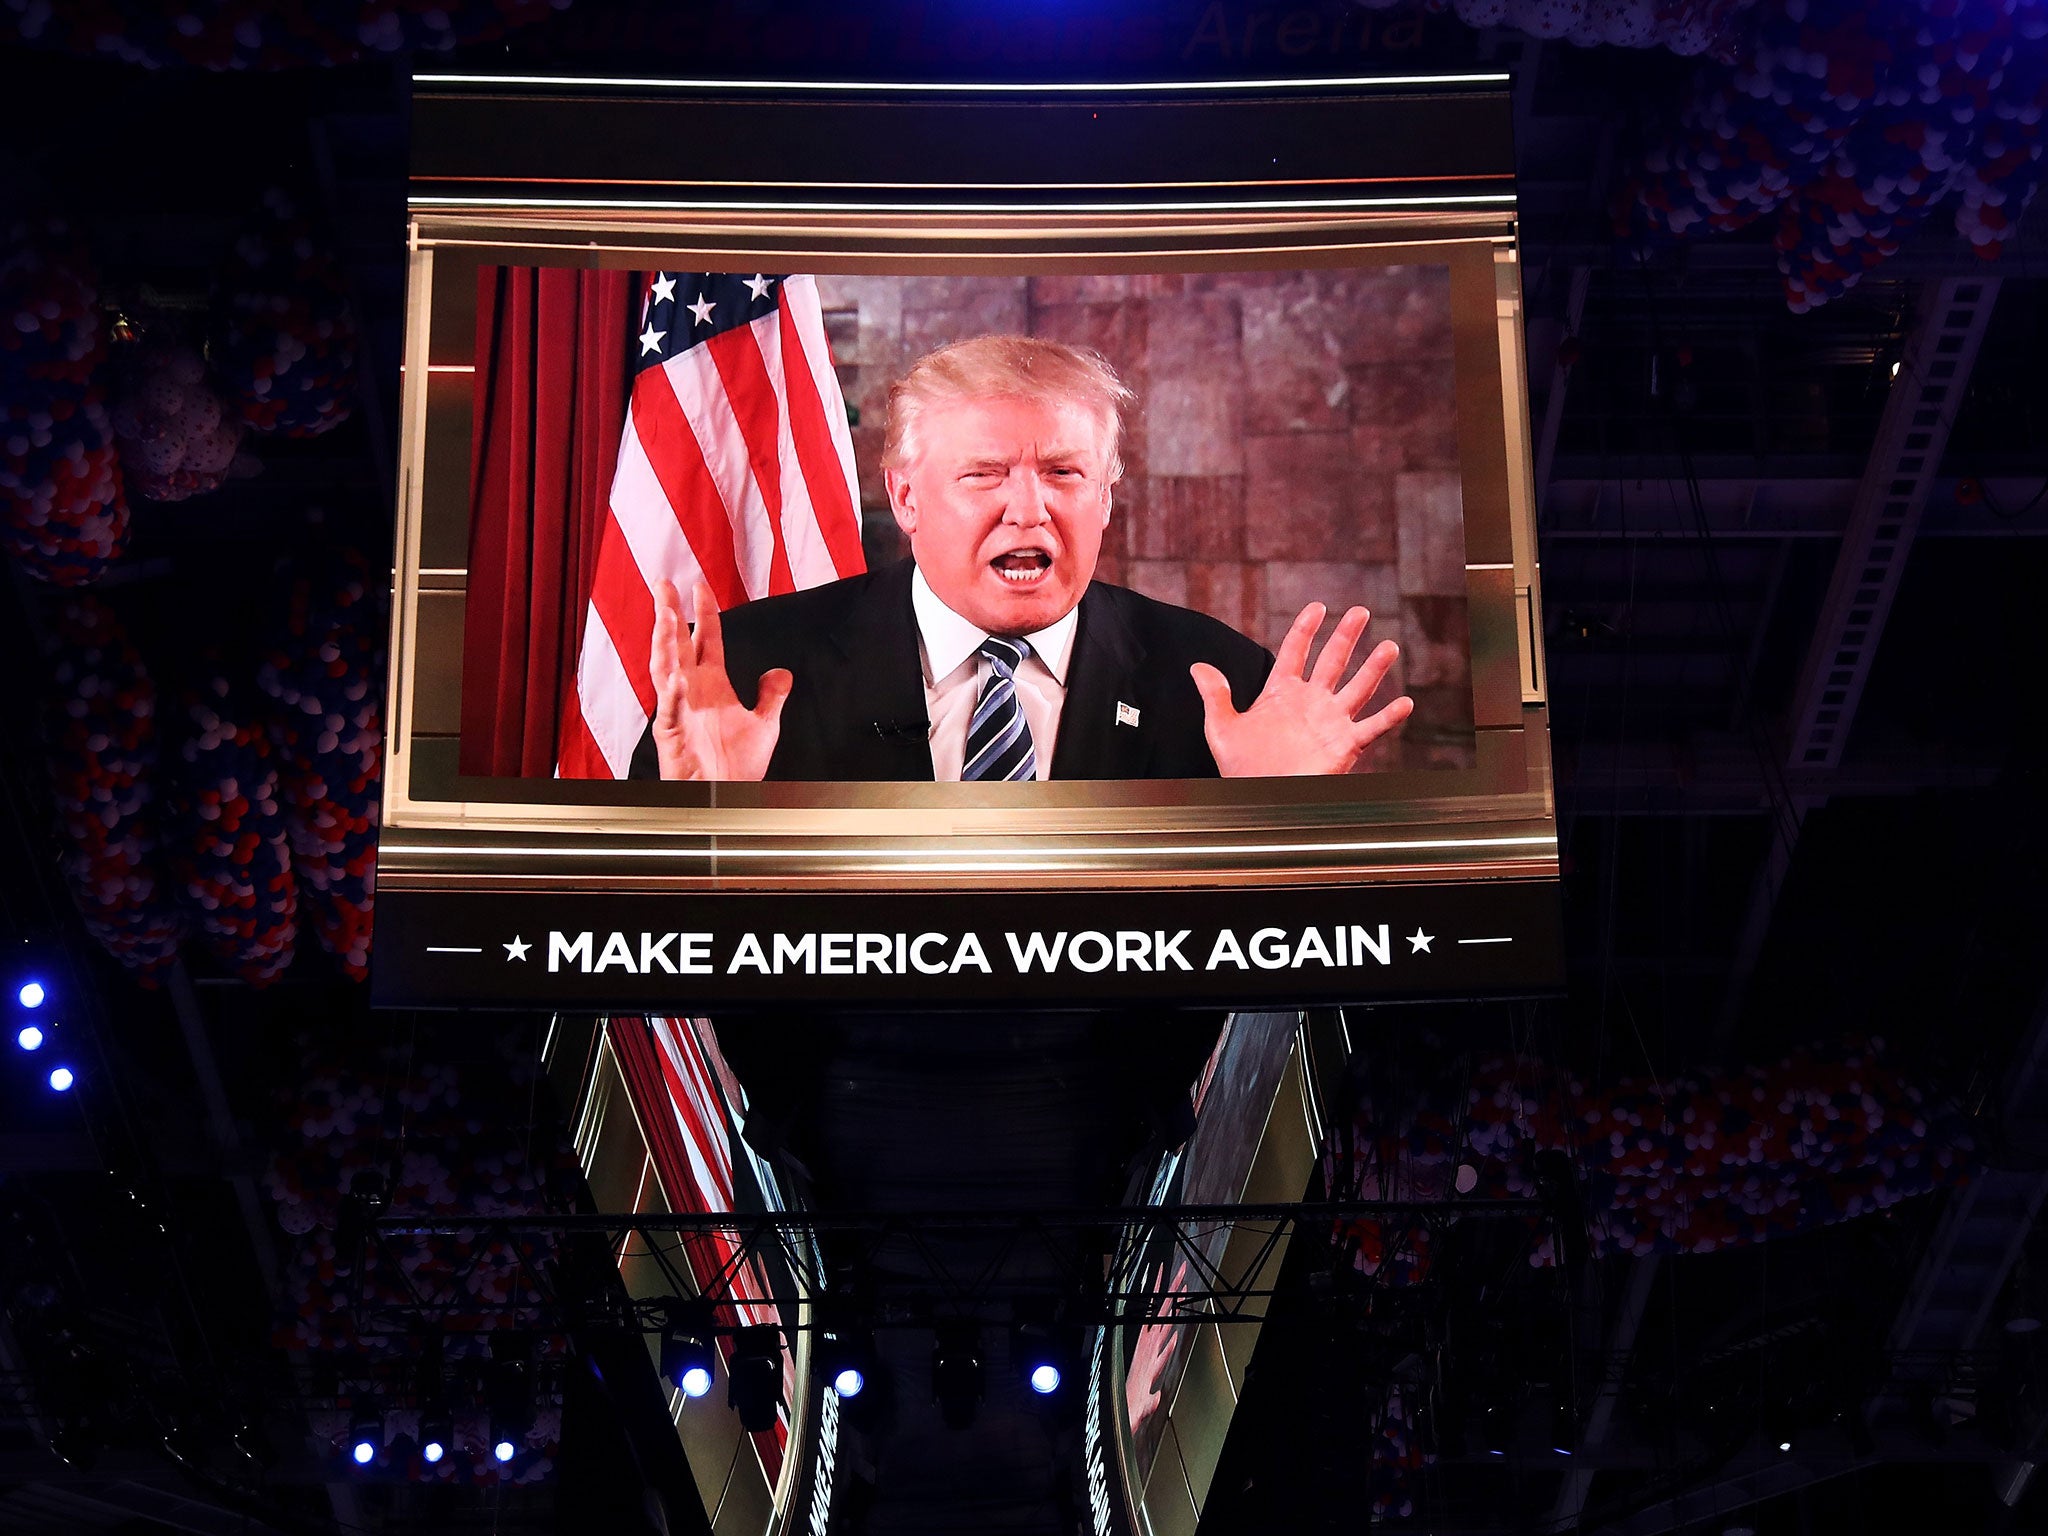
<box><xmin>647</xmin><ymin>582</ymin><xmax>795</xmax><ymax>782</ymax></box>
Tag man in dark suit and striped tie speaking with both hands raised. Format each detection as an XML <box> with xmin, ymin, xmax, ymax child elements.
<box><xmin>635</xmin><ymin>336</ymin><xmax>1413</xmax><ymax>782</ymax></box>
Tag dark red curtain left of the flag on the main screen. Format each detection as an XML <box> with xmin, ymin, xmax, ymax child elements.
<box><xmin>461</xmin><ymin>266</ymin><xmax>639</xmax><ymax>778</ymax></box>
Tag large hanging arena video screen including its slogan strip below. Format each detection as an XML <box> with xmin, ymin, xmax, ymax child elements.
<box><xmin>379</xmin><ymin>82</ymin><xmax>1556</xmax><ymax>1006</ymax></box>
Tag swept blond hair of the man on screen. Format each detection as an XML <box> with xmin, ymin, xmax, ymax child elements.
<box><xmin>883</xmin><ymin>336</ymin><xmax>1137</xmax><ymax>479</ymax></box>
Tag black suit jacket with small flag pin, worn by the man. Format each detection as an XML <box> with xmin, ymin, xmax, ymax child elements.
<box><xmin>633</xmin><ymin>561</ymin><xmax>1274</xmax><ymax>782</ymax></box>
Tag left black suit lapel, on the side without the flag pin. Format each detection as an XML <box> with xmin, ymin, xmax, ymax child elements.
<box><xmin>819</xmin><ymin>559</ymin><xmax>932</xmax><ymax>780</ymax></box>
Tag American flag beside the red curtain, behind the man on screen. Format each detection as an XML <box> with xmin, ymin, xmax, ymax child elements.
<box><xmin>557</xmin><ymin>272</ymin><xmax>866</xmax><ymax>778</ymax></box>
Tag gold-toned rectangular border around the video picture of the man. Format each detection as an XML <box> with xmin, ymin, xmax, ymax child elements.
<box><xmin>381</xmin><ymin>153</ymin><xmax>1556</xmax><ymax>891</ymax></box>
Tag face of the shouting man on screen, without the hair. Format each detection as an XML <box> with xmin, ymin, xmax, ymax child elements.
<box><xmin>889</xmin><ymin>397</ymin><xmax>1110</xmax><ymax>635</ymax></box>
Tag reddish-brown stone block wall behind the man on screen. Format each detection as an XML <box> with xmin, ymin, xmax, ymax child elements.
<box><xmin>817</xmin><ymin>266</ymin><xmax>1475</xmax><ymax>768</ymax></box>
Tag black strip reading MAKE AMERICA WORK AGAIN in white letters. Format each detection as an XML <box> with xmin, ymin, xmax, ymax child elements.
<box><xmin>373</xmin><ymin>881</ymin><xmax>1563</xmax><ymax>1010</ymax></box>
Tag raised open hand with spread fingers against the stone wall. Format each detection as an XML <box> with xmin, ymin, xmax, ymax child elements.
<box><xmin>1188</xmin><ymin>602</ymin><xmax>1415</xmax><ymax>778</ymax></box>
